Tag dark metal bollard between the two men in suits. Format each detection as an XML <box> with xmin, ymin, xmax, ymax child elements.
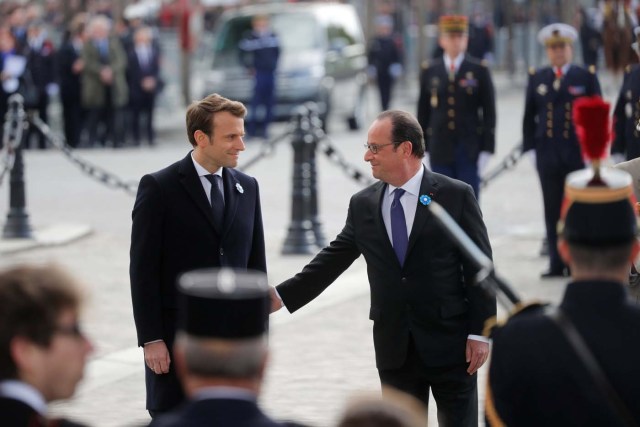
<box><xmin>282</xmin><ymin>106</ymin><xmax>317</xmax><ymax>255</ymax></box>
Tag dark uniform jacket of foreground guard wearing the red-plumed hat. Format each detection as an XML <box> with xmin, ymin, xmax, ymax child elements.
<box><xmin>489</xmin><ymin>281</ymin><xmax>640</xmax><ymax>427</ymax></box>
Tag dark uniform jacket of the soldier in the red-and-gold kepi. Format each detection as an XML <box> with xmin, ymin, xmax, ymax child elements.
<box><xmin>418</xmin><ymin>55</ymin><xmax>496</xmax><ymax>164</ymax></box>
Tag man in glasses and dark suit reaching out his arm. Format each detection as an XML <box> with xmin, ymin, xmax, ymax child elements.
<box><xmin>272</xmin><ymin>110</ymin><xmax>496</xmax><ymax>426</ymax></box>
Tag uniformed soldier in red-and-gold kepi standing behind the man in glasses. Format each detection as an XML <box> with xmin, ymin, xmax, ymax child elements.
<box><xmin>418</xmin><ymin>16</ymin><xmax>496</xmax><ymax>197</ymax></box>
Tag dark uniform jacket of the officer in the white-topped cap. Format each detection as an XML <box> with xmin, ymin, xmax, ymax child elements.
<box><xmin>522</xmin><ymin>65</ymin><xmax>601</xmax><ymax>173</ymax></box>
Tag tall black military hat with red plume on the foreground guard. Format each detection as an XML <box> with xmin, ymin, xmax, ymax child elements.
<box><xmin>558</xmin><ymin>97</ymin><xmax>637</xmax><ymax>247</ymax></box>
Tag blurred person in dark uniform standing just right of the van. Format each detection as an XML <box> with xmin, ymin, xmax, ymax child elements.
<box><xmin>368</xmin><ymin>15</ymin><xmax>402</xmax><ymax>111</ymax></box>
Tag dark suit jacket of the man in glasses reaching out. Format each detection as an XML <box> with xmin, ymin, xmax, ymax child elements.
<box><xmin>277</xmin><ymin>169</ymin><xmax>496</xmax><ymax>369</ymax></box>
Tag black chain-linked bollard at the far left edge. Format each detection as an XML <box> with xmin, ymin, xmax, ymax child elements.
<box><xmin>2</xmin><ymin>94</ymin><xmax>33</xmax><ymax>239</ymax></box>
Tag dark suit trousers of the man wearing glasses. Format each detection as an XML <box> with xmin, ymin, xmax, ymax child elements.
<box><xmin>378</xmin><ymin>339</ymin><xmax>478</xmax><ymax>427</ymax></box>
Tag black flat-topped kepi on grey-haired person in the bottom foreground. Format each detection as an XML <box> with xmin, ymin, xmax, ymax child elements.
<box><xmin>178</xmin><ymin>268</ymin><xmax>270</xmax><ymax>340</ymax></box>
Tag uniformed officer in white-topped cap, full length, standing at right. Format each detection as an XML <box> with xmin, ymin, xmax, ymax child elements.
<box><xmin>522</xmin><ymin>23</ymin><xmax>600</xmax><ymax>278</ymax></box>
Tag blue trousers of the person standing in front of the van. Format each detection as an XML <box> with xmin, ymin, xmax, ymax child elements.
<box><xmin>247</xmin><ymin>71</ymin><xmax>276</xmax><ymax>137</ymax></box>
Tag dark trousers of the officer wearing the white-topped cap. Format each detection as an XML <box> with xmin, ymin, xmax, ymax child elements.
<box><xmin>538</xmin><ymin>170</ymin><xmax>570</xmax><ymax>272</ymax></box>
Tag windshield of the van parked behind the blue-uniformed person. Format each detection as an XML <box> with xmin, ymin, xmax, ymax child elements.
<box><xmin>214</xmin><ymin>13</ymin><xmax>323</xmax><ymax>64</ymax></box>
